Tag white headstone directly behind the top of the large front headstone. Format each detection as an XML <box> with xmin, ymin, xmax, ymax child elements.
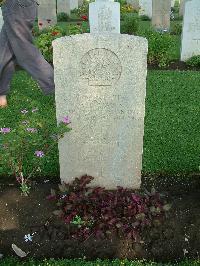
<box><xmin>89</xmin><ymin>1</ymin><xmax>120</xmax><ymax>33</ymax></box>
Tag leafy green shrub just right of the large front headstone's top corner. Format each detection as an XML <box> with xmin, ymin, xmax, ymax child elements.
<box><xmin>139</xmin><ymin>30</ymin><xmax>174</xmax><ymax>67</ymax></box>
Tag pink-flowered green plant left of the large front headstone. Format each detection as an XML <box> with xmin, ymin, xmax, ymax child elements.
<box><xmin>0</xmin><ymin>108</ymin><xmax>71</xmax><ymax>196</ymax></box>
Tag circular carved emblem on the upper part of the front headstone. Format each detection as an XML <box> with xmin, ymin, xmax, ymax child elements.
<box><xmin>80</xmin><ymin>48</ymin><xmax>122</xmax><ymax>86</ymax></box>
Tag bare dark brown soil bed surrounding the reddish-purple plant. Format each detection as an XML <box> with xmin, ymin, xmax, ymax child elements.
<box><xmin>0</xmin><ymin>175</ymin><xmax>200</xmax><ymax>261</ymax></box>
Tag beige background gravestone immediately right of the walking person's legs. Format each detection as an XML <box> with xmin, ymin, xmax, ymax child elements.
<box><xmin>38</xmin><ymin>0</ymin><xmax>57</xmax><ymax>30</ymax></box>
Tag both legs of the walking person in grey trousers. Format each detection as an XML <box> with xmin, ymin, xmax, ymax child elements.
<box><xmin>0</xmin><ymin>0</ymin><xmax>55</xmax><ymax>107</ymax></box>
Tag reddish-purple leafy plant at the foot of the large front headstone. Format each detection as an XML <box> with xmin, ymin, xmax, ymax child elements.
<box><xmin>48</xmin><ymin>175</ymin><xmax>170</xmax><ymax>242</ymax></box>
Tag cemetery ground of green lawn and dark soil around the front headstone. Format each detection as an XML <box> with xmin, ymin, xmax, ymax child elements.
<box><xmin>0</xmin><ymin>70</ymin><xmax>200</xmax><ymax>265</ymax></box>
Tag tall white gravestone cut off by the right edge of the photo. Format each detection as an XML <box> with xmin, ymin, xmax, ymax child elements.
<box><xmin>181</xmin><ymin>0</ymin><xmax>200</xmax><ymax>61</ymax></box>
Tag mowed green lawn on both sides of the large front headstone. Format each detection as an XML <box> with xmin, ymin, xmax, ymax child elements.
<box><xmin>0</xmin><ymin>71</ymin><xmax>200</xmax><ymax>180</ymax></box>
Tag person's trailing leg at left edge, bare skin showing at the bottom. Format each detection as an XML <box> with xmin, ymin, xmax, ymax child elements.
<box><xmin>0</xmin><ymin>26</ymin><xmax>15</xmax><ymax>107</ymax></box>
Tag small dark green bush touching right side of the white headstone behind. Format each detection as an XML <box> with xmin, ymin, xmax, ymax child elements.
<box><xmin>121</xmin><ymin>14</ymin><xmax>139</xmax><ymax>34</ymax></box>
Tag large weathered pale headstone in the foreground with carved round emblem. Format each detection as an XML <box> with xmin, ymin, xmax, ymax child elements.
<box><xmin>53</xmin><ymin>33</ymin><xmax>147</xmax><ymax>188</ymax></box>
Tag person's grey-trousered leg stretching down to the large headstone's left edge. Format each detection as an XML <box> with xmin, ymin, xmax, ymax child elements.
<box><xmin>4</xmin><ymin>3</ymin><xmax>55</xmax><ymax>94</ymax></box>
